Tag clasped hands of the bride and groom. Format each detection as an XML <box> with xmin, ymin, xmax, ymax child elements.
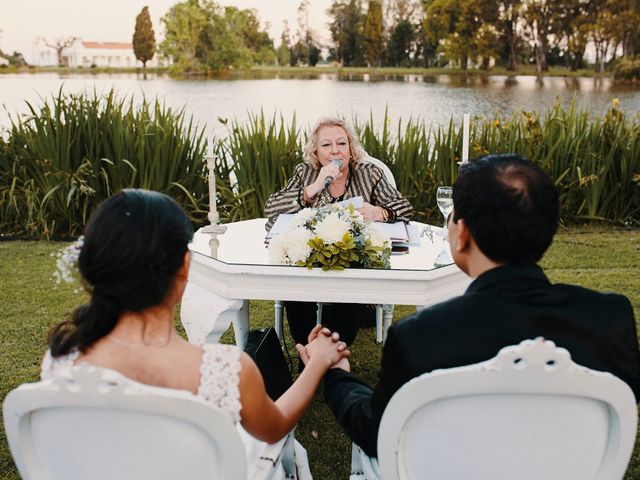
<box><xmin>296</xmin><ymin>325</ymin><xmax>351</xmax><ymax>372</ymax></box>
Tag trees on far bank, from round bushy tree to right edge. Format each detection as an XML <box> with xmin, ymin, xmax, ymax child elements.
<box><xmin>159</xmin><ymin>0</ymin><xmax>640</xmax><ymax>72</ymax></box>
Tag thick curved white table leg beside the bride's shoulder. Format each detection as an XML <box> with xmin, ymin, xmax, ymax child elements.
<box><xmin>180</xmin><ymin>282</ymin><xmax>249</xmax><ymax>348</ymax></box>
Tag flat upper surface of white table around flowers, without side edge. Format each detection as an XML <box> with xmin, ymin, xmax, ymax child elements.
<box><xmin>189</xmin><ymin>218</ymin><xmax>452</xmax><ymax>275</ymax></box>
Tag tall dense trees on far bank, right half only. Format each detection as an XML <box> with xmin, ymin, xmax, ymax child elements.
<box><xmin>328</xmin><ymin>0</ymin><xmax>640</xmax><ymax>71</ymax></box>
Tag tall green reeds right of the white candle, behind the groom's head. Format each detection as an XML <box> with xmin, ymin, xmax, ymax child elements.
<box><xmin>472</xmin><ymin>100</ymin><xmax>640</xmax><ymax>225</ymax></box>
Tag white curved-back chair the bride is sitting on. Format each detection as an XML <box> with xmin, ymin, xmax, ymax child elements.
<box><xmin>3</xmin><ymin>363</ymin><xmax>302</xmax><ymax>480</ymax></box>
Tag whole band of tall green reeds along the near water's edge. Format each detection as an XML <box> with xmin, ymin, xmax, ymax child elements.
<box><xmin>0</xmin><ymin>91</ymin><xmax>640</xmax><ymax>238</ymax></box>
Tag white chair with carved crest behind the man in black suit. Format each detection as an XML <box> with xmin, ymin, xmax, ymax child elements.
<box><xmin>352</xmin><ymin>338</ymin><xmax>638</xmax><ymax>480</ymax></box>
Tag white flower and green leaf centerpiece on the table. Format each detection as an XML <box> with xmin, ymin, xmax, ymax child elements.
<box><xmin>269</xmin><ymin>204</ymin><xmax>391</xmax><ymax>271</ymax></box>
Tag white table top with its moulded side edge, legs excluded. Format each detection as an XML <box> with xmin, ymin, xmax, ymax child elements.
<box><xmin>185</xmin><ymin>218</ymin><xmax>470</xmax><ymax>305</ymax></box>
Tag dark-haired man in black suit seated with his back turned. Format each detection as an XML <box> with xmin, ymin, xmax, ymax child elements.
<box><xmin>308</xmin><ymin>154</ymin><xmax>640</xmax><ymax>456</ymax></box>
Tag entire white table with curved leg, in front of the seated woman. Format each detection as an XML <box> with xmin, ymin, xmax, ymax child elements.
<box><xmin>181</xmin><ymin>218</ymin><xmax>470</xmax><ymax>347</ymax></box>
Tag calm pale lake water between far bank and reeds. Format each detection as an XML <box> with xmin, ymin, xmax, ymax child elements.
<box><xmin>0</xmin><ymin>73</ymin><xmax>640</xmax><ymax>136</ymax></box>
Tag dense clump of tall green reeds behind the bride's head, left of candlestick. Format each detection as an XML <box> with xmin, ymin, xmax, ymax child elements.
<box><xmin>0</xmin><ymin>90</ymin><xmax>208</xmax><ymax>238</ymax></box>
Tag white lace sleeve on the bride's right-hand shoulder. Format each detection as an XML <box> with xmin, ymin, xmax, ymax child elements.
<box><xmin>198</xmin><ymin>344</ymin><xmax>242</xmax><ymax>423</ymax></box>
